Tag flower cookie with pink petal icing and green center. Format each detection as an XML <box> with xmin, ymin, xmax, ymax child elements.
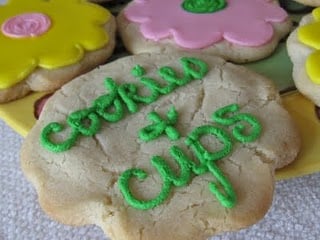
<box><xmin>117</xmin><ymin>0</ymin><xmax>291</xmax><ymax>62</ymax></box>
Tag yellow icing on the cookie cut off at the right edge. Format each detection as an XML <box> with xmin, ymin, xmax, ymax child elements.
<box><xmin>298</xmin><ymin>8</ymin><xmax>320</xmax><ymax>84</ymax></box>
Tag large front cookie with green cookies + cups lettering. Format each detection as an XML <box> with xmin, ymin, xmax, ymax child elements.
<box><xmin>21</xmin><ymin>54</ymin><xmax>300</xmax><ymax>240</ymax></box>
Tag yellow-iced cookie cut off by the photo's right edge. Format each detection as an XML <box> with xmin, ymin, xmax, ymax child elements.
<box><xmin>287</xmin><ymin>8</ymin><xmax>320</xmax><ymax>106</ymax></box>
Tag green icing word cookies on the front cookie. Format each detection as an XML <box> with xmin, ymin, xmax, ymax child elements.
<box><xmin>40</xmin><ymin>57</ymin><xmax>208</xmax><ymax>152</ymax></box>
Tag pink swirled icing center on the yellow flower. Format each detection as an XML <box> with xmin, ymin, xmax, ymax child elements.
<box><xmin>1</xmin><ymin>13</ymin><xmax>51</xmax><ymax>38</ymax></box>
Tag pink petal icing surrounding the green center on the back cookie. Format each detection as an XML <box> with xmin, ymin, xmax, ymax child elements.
<box><xmin>124</xmin><ymin>0</ymin><xmax>288</xmax><ymax>49</ymax></box>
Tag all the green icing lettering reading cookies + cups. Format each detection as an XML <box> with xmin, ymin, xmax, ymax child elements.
<box><xmin>40</xmin><ymin>58</ymin><xmax>262</xmax><ymax>210</ymax></box>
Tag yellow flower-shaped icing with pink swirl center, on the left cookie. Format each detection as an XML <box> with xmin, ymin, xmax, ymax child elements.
<box><xmin>0</xmin><ymin>0</ymin><xmax>111</xmax><ymax>90</ymax></box>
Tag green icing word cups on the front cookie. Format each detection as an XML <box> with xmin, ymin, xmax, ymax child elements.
<box><xmin>119</xmin><ymin>104</ymin><xmax>261</xmax><ymax>210</ymax></box>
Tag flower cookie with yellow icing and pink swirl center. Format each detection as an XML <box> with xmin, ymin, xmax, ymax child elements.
<box><xmin>0</xmin><ymin>0</ymin><xmax>115</xmax><ymax>103</ymax></box>
